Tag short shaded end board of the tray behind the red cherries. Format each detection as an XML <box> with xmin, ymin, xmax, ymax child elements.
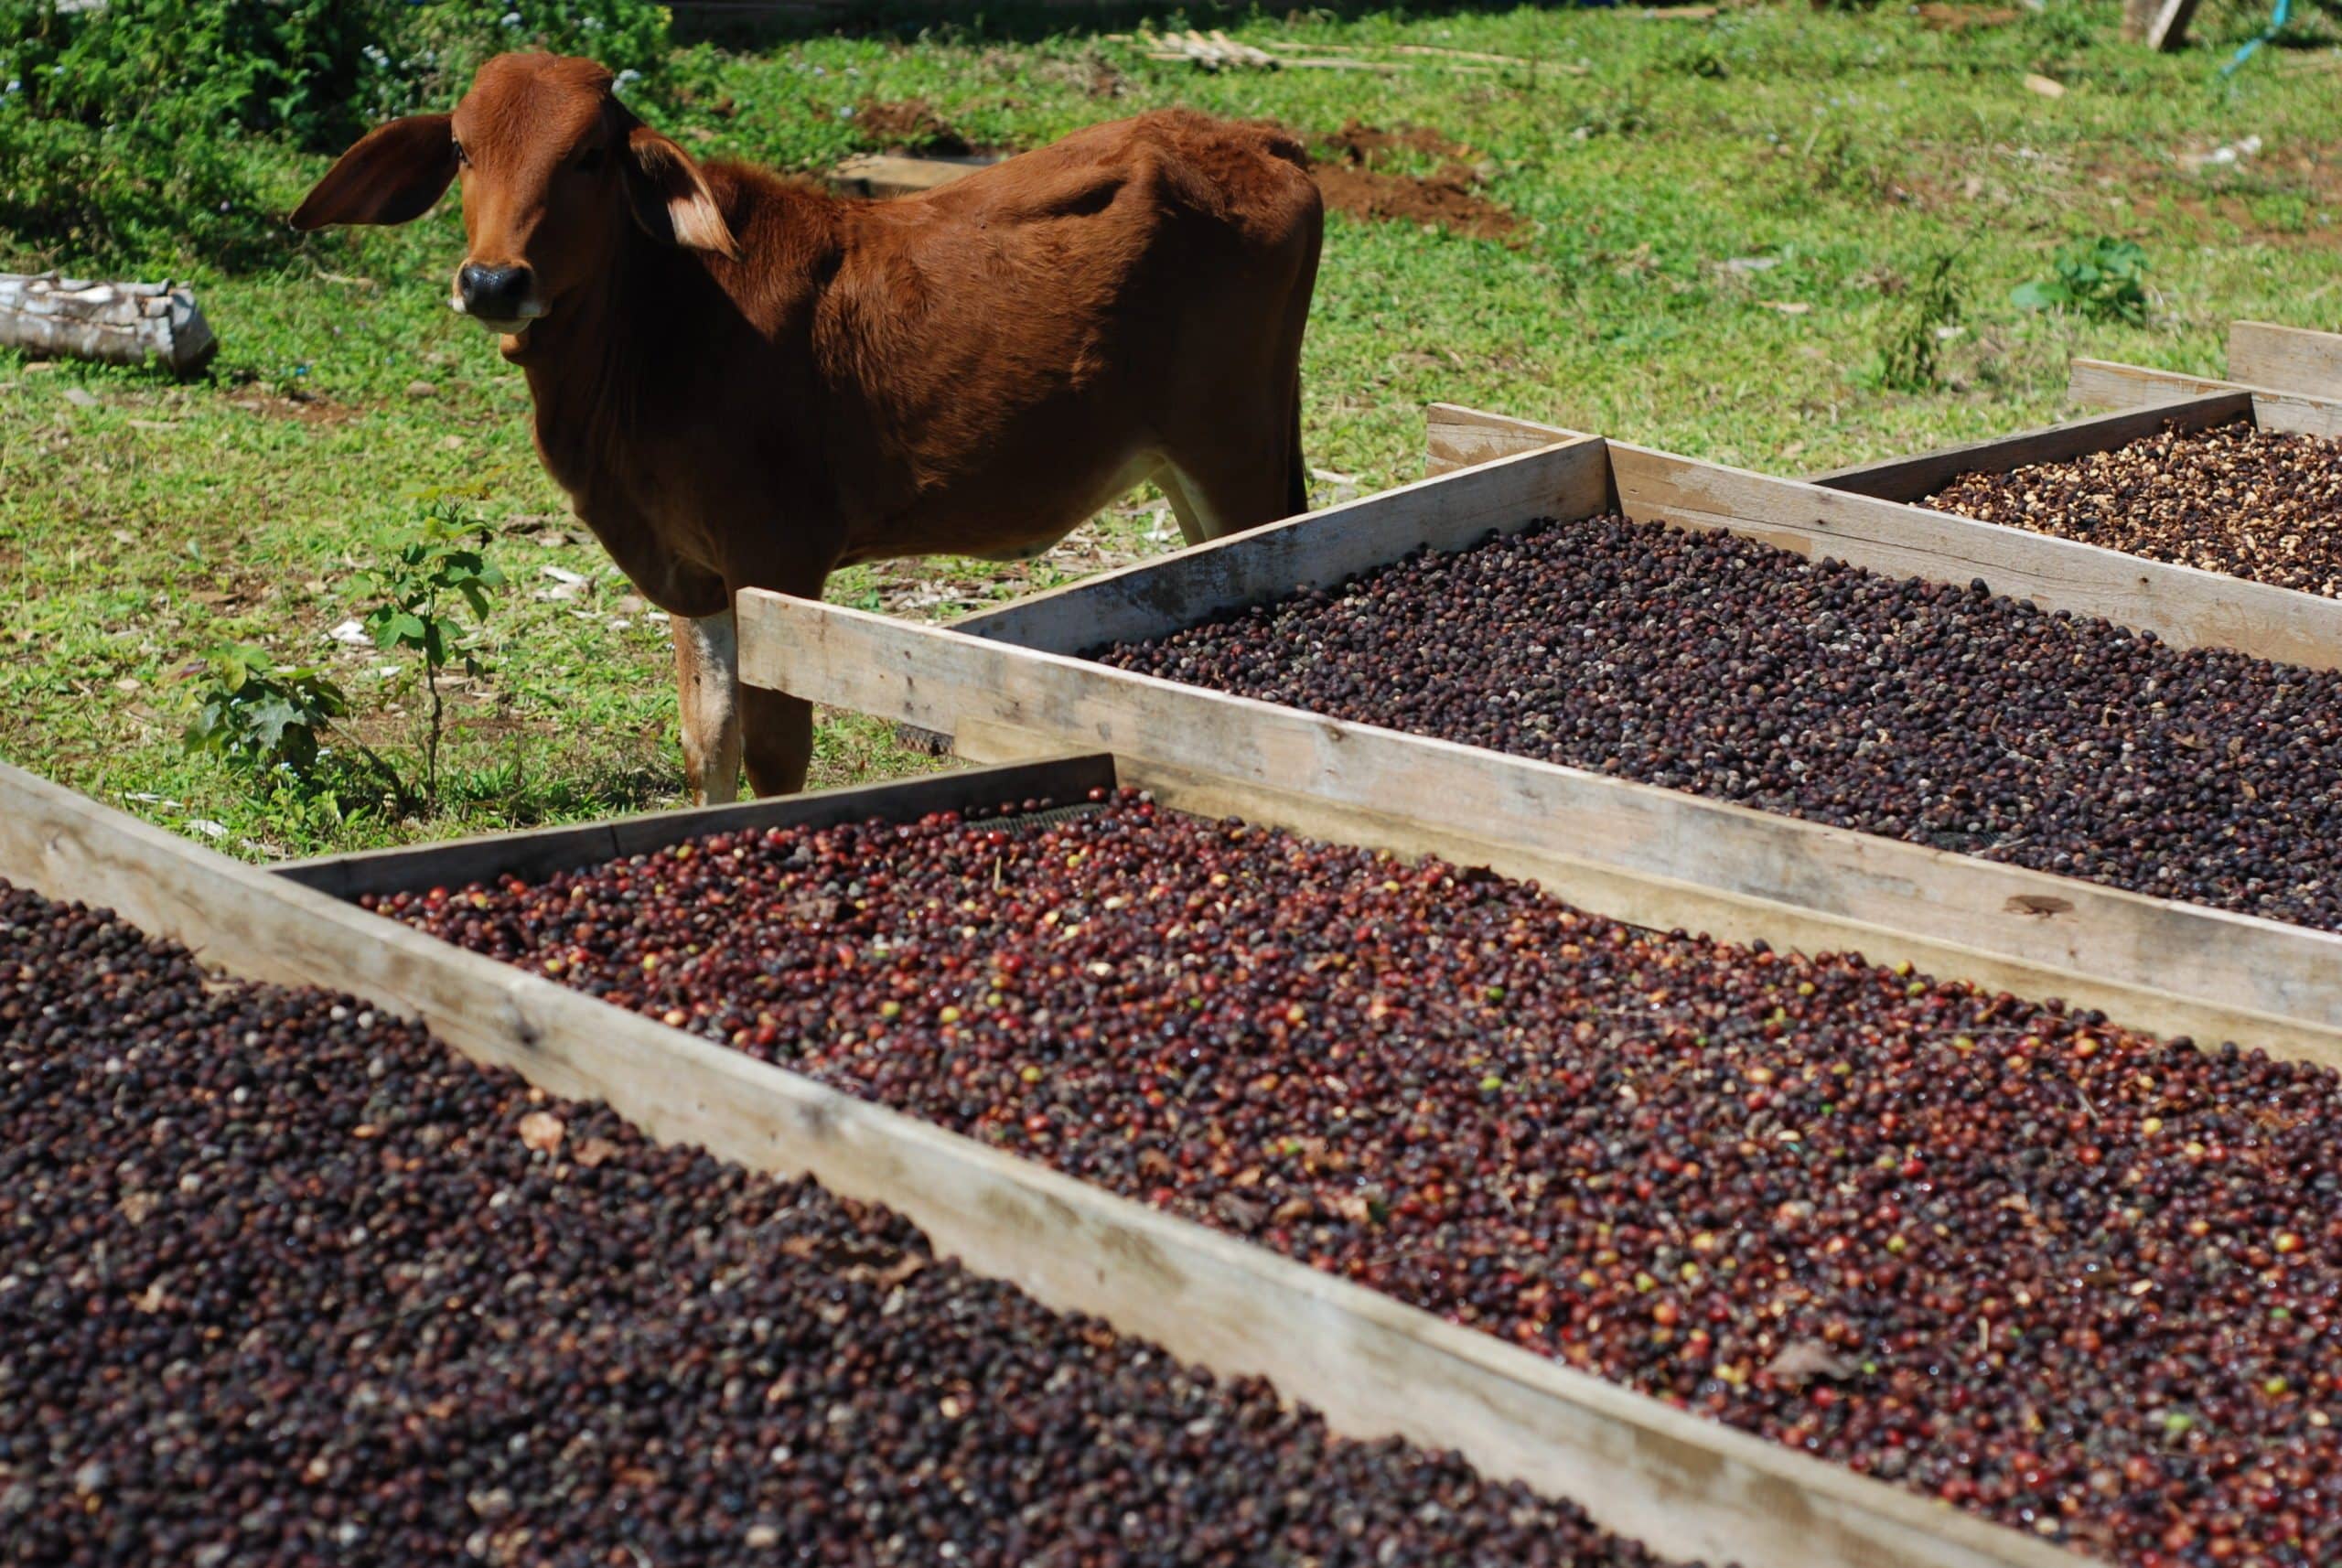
<box><xmin>958</xmin><ymin>440</ymin><xmax>1611</xmax><ymax>653</ymax></box>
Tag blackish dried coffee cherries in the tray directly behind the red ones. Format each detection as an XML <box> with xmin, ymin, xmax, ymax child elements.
<box><xmin>1099</xmin><ymin>517</ymin><xmax>2342</xmax><ymax>929</ymax></box>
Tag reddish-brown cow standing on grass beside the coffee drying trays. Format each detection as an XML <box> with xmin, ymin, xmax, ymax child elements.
<box><xmin>293</xmin><ymin>54</ymin><xmax>1323</xmax><ymax>800</ymax></box>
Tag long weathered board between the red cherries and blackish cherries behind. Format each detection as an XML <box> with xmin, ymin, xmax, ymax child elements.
<box><xmin>737</xmin><ymin>590</ymin><xmax>2342</xmax><ymax>1080</ymax></box>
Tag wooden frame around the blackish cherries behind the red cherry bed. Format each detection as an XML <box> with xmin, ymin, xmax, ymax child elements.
<box><xmin>737</xmin><ymin>440</ymin><xmax>2342</xmax><ymax>1065</ymax></box>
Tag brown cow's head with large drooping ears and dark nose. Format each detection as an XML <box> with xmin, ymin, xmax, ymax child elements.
<box><xmin>293</xmin><ymin>54</ymin><xmax>737</xmax><ymax>346</ymax></box>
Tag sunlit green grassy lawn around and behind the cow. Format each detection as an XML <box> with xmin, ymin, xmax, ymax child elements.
<box><xmin>0</xmin><ymin>0</ymin><xmax>2342</xmax><ymax>856</ymax></box>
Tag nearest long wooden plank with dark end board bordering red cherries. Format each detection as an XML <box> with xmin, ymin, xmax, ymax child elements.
<box><xmin>0</xmin><ymin>756</ymin><xmax>2084</xmax><ymax>1568</ymax></box>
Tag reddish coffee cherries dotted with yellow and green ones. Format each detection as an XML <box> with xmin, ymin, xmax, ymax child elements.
<box><xmin>398</xmin><ymin>796</ymin><xmax>2342</xmax><ymax>1568</ymax></box>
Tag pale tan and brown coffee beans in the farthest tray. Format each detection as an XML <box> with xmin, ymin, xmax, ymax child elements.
<box><xmin>1920</xmin><ymin>424</ymin><xmax>2342</xmax><ymax>599</ymax></box>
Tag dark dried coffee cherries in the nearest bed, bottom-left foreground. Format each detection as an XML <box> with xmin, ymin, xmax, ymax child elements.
<box><xmin>0</xmin><ymin>885</ymin><xmax>1686</xmax><ymax>1568</ymax></box>
